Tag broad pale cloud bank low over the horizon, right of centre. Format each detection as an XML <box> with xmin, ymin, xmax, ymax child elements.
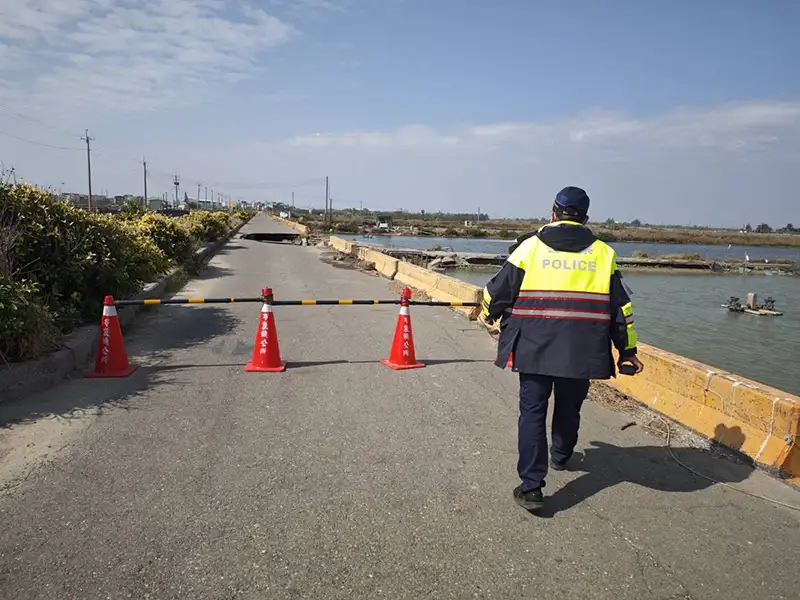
<box><xmin>250</xmin><ymin>101</ymin><xmax>800</xmax><ymax>226</ymax></box>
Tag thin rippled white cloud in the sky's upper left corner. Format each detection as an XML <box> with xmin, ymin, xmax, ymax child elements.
<box><xmin>0</xmin><ymin>0</ymin><xmax>298</xmax><ymax>114</ymax></box>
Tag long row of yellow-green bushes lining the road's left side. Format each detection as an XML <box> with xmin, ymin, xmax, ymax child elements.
<box><xmin>0</xmin><ymin>184</ymin><xmax>252</xmax><ymax>362</ymax></box>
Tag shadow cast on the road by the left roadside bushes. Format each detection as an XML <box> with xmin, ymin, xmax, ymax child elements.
<box><xmin>0</xmin><ymin>306</ymin><xmax>239</xmax><ymax>429</ymax></box>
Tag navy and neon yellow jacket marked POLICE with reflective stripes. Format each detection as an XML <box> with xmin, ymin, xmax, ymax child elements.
<box><xmin>483</xmin><ymin>221</ymin><xmax>637</xmax><ymax>379</ymax></box>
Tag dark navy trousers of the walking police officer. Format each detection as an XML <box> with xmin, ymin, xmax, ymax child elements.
<box><xmin>517</xmin><ymin>373</ymin><xmax>589</xmax><ymax>492</ymax></box>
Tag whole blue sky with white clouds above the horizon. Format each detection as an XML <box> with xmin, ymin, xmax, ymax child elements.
<box><xmin>0</xmin><ymin>0</ymin><xmax>800</xmax><ymax>226</ymax></box>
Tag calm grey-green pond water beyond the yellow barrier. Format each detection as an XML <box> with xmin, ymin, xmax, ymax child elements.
<box><xmin>354</xmin><ymin>236</ymin><xmax>800</xmax><ymax>395</ymax></box>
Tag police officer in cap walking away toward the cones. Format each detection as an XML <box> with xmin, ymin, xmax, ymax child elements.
<box><xmin>483</xmin><ymin>187</ymin><xmax>644</xmax><ymax>510</ymax></box>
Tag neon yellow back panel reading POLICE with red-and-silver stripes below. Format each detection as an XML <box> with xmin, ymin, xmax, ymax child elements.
<box><xmin>511</xmin><ymin>238</ymin><xmax>616</xmax><ymax>322</ymax></box>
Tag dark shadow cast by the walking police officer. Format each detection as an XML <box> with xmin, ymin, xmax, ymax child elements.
<box><xmin>533</xmin><ymin>424</ymin><xmax>754</xmax><ymax>518</ymax></box>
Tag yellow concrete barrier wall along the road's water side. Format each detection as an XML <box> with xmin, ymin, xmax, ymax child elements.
<box><xmin>324</xmin><ymin>237</ymin><xmax>800</xmax><ymax>486</ymax></box>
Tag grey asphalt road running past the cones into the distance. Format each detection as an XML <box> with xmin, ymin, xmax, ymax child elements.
<box><xmin>0</xmin><ymin>217</ymin><xmax>800</xmax><ymax>600</ymax></box>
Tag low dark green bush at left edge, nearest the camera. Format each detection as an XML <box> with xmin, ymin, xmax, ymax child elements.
<box><xmin>0</xmin><ymin>277</ymin><xmax>58</xmax><ymax>362</ymax></box>
